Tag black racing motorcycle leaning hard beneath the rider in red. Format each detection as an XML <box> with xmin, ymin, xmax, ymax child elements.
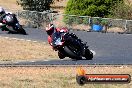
<box><xmin>52</xmin><ymin>29</ymin><xmax>93</xmax><ymax>60</ymax></box>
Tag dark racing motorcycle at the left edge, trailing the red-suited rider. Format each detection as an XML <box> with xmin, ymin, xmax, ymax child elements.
<box><xmin>2</xmin><ymin>14</ymin><xmax>27</xmax><ymax>35</ymax></box>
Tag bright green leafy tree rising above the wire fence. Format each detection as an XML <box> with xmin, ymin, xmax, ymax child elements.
<box><xmin>65</xmin><ymin>0</ymin><xmax>122</xmax><ymax>17</ymax></box>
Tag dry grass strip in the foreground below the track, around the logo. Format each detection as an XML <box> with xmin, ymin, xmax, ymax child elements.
<box><xmin>0</xmin><ymin>67</ymin><xmax>132</xmax><ymax>88</ymax></box>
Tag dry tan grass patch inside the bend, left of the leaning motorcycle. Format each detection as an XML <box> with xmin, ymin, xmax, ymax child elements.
<box><xmin>0</xmin><ymin>37</ymin><xmax>58</xmax><ymax>61</ymax></box>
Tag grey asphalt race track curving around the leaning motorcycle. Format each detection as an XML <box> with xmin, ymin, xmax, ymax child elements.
<box><xmin>0</xmin><ymin>28</ymin><xmax>132</xmax><ymax>65</ymax></box>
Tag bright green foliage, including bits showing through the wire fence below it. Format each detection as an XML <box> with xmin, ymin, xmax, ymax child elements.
<box><xmin>64</xmin><ymin>0</ymin><xmax>122</xmax><ymax>25</ymax></box>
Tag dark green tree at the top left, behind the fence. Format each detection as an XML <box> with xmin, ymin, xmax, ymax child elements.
<box><xmin>17</xmin><ymin>0</ymin><xmax>53</xmax><ymax>12</ymax></box>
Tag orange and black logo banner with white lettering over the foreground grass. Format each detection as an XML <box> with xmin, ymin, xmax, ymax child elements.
<box><xmin>76</xmin><ymin>68</ymin><xmax>131</xmax><ymax>85</ymax></box>
